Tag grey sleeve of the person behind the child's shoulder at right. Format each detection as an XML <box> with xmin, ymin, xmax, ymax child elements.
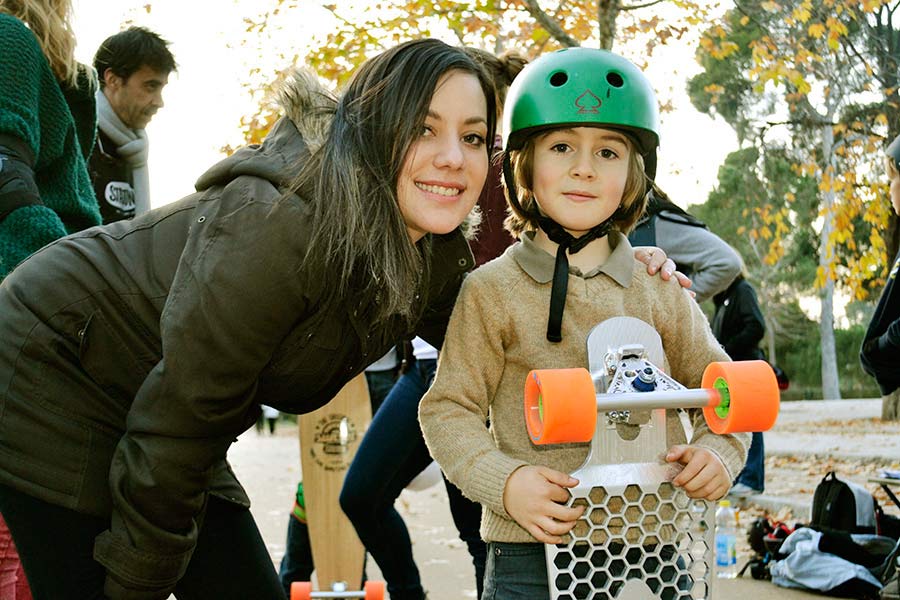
<box><xmin>656</xmin><ymin>217</ymin><xmax>741</xmax><ymax>302</ymax></box>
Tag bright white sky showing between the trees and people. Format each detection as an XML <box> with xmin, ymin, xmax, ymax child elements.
<box><xmin>73</xmin><ymin>0</ymin><xmax>737</xmax><ymax>207</ymax></box>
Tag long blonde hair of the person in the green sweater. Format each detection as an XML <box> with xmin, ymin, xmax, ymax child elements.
<box><xmin>0</xmin><ymin>0</ymin><xmax>84</xmax><ymax>87</ymax></box>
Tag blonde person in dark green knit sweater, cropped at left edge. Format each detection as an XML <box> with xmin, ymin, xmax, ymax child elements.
<box><xmin>0</xmin><ymin>0</ymin><xmax>100</xmax><ymax>279</ymax></box>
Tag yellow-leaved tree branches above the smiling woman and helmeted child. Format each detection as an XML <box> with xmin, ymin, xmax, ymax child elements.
<box><xmin>229</xmin><ymin>0</ymin><xmax>719</xmax><ymax>152</ymax></box>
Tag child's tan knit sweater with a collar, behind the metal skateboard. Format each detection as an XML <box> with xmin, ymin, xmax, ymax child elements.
<box><xmin>419</xmin><ymin>232</ymin><xmax>750</xmax><ymax>542</ymax></box>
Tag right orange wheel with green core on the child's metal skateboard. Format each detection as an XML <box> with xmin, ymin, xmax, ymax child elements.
<box><xmin>702</xmin><ymin>360</ymin><xmax>780</xmax><ymax>434</ymax></box>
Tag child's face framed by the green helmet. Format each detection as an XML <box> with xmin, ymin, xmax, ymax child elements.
<box><xmin>533</xmin><ymin>127</ymin><xmax>631</xmax><ymax>237</ymax></box>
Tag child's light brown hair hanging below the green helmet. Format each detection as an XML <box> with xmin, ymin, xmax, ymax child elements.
<box><xmin>503</xmin><ymin>131</ymin><xmax>648</xmax><ymax>237</ymax></box>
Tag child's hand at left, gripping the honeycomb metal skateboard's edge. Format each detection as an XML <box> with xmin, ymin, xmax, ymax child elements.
<box><xmin>503</xmin><ymin>465</ymin><xmax>584</xmax><ymax>544</ymax></box>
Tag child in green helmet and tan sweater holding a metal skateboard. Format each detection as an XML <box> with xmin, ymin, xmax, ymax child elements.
<box><xmin>419</xmin><ymin>48</ymin><xmax>749</xmax><ymax>600</ymax></box>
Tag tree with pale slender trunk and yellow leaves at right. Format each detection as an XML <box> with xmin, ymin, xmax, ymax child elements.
<box><xmin>689</xmin><ymin>0</ymin><xmax>888</xmax><ymax>398</ymax></box>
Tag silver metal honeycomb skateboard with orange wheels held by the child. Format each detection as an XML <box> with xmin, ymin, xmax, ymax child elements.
<box><xmin>525</xmin><ymin>317</ymin><xmax>779</xmax><ymax>600</ymax></box>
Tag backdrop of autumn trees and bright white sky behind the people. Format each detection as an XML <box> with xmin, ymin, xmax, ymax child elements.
<box><xmin>74</xmin><ymin>0</ymin><xmax>900</xmax><ymax>399</ymax></box>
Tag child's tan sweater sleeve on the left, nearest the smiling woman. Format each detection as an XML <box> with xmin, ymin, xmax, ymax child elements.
<box><xmin>419</xmin><ymin>271</ymin><xmax>527</xmax><ymax>518</ymax></box>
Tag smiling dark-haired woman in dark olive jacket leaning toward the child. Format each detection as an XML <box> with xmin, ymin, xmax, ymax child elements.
<box><xmin>0</xmin><ymin>40</ymin><xmax>495</xmax><ymax>598</ymax></box>
